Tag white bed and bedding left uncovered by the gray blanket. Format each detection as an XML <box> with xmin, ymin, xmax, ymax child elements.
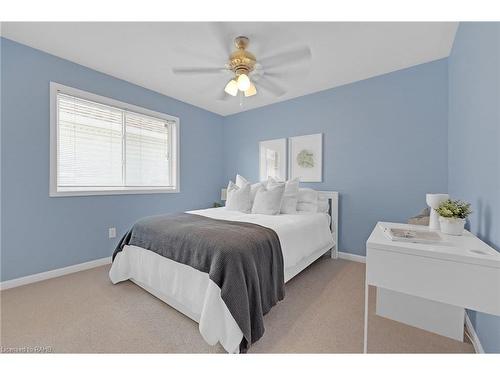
<box><xmin>109</xmin><ymin>191</ymin><xmax>338</xmax><ymax>353</ymax></box>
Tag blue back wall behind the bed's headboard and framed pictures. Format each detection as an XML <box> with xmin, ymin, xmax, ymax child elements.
<box><xmin>224</xmin><ymin>60</ymin><xmax>448</xmax><ymax>255</ymax></box>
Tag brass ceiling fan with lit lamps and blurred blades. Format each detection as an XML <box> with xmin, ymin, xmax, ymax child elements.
<box><xmin>172</xmin><ymin>36</ymin><xmax>311</xmax><ymax>100</ymax></box>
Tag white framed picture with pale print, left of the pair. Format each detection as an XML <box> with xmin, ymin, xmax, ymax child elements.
<box><xmin>259</xmin><ymin>138</ymin><xmax>287</xmax><ymax>181</ymax></box>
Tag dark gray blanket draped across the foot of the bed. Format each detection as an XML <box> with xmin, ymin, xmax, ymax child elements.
<box><xmin>113</xmin><ymin>213</ymin><xmax>285</xmax><ymax>352</ymax></box>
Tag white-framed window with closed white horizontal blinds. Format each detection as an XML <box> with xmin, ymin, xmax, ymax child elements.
<box><xmin>50</xmin><ymin>83</ymin><xmax>179</xmax><ymax>196</ymax></box>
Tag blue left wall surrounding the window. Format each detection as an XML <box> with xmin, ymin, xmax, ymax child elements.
<box><xmin>1</xmin><ymin>39</ymin><xmax>223</xmax><ymax>280</ymax></box>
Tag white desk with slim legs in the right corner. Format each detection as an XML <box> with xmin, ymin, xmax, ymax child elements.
<box><xmin>364</xmin><ymin>223</ymin><xmax>500</xmax><ymax>353</ymax></box>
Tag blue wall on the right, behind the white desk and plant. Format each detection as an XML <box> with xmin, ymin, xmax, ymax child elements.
<box><xmin>448</xmin><ymin>23</ymin><xmax>500</xmax><ymax>353</ymax></box>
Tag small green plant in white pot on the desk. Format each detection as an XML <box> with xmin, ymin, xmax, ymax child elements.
<box><xmin>436</xmin><ymin>199</ymin><xmax>472</xmax><ymax>236</ymax></box>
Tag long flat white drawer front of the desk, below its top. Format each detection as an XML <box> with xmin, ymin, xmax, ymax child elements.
<box><xmin>366</xmin><ymin>246</ymin><xmax>500</xmax><ymax>315</ymax></box>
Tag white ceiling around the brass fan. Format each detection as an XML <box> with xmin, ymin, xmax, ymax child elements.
<box><xmin>2</xmin><ymin>22</ymin><xmax>458</xmax><ymax>115</ymax></box>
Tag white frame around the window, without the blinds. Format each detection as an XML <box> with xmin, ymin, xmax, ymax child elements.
<box><xmin>49</xmin><ymin>82</ymin><xmax>180</xmax><ymax>197</ymax></box>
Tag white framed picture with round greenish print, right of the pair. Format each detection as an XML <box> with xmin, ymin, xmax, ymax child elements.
<box><xmin>288</xmin><ymin>133</ymin><xmax>323</xmax><ymax>182</ymax></box>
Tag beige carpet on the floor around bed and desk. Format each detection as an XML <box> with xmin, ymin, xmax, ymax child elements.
<box><xmin>0</xmin><ymin>258</ymin><xmax>473</xmax><ymax>353</ymax></box>
